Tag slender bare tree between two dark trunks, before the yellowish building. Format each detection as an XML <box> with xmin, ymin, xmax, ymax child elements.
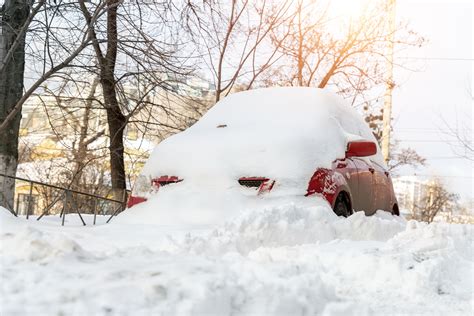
<box><xmin>18</xmin><ymin>79</ymin><xmax>110</xmax><ymax>213</ymax></box>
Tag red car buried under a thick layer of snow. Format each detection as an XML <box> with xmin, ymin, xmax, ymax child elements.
<box><xmin>128</xmin><ymin>87</ymin><xmax>399</xmax><ymax>220</ymax></box>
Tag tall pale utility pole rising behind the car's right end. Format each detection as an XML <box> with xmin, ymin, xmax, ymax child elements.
<box><xmin>382</xmin><ymin>0</ymin><xmax>396</xmax><ymax>163</ymax></box>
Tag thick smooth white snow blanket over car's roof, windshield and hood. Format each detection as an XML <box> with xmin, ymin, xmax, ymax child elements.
<box><xmin>143</xmin><ymin>87</ymin><xmax>381</xmax><ymax>193</ymax></box>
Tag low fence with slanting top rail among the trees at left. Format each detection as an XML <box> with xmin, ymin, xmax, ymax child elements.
<box><xmin>0</xmin><ymin>173</ymin><xmax>128</xmax><ymax>226</ymax></box>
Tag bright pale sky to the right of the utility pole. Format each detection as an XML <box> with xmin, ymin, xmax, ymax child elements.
<box><xmin>393</xmin><ymin>0</ymin><xmax>474</xmax><ymax>199</ymax></box>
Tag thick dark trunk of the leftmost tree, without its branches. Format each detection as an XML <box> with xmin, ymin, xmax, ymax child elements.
<box><xmin>0</xmin><ymin>0</ymin><xmax>30</xmax><ymax>210</ymax></box>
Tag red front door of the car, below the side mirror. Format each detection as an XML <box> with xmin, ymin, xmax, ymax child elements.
<box><xmin>350</xmin><ymin>157</ymin><xmax>375</xmax><ymax>215</ymax></box>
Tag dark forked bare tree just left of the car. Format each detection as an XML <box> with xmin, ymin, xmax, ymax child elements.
<box><xmin>79</xmin><ymin>0</ymin><xmax>196</xmax><ymax>195</ymax></box>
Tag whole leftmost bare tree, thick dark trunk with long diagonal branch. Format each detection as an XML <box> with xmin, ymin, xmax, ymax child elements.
<box><xmin>0</xmin><ymin>0</ymin><xmax>103</xmax><ymax>209</ymax></box>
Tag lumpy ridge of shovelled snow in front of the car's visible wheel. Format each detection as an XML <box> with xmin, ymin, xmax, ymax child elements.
<box><xmin>176</xmin><ymin>203</ymin><xmax>406</xmax><ymax>255</ymax></box>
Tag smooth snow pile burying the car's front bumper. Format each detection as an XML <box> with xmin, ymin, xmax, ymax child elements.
<box><xmin>114</xmin><ymin>181</ymin><xmax>329</xmax><ymax>228</ymax></box>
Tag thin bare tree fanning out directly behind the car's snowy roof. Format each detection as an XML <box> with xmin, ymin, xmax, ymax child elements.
<box><xmin>187</xmin><ymin>0</ymin><xmax>293</xmax><ymax>102</ymax></box>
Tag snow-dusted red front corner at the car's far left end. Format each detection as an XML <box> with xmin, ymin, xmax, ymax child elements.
<box><xmin>127</xmin><ymin>176</ymin><xmax>183</xmax><ymax>207</ymax></box>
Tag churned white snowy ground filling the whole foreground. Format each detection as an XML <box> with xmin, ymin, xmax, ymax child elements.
<box><xmin>0</xmin><ymin>204</ymin><xmax>474</xmax><ymax>315</ymax></box>
